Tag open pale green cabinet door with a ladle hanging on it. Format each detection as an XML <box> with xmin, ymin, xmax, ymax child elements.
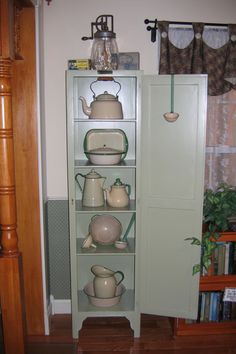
<box><xmin>140</xmin><ymin>75</ymin><xmax>207</xmax><ymax>318</ymax></box>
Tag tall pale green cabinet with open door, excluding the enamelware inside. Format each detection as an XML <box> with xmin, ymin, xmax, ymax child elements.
<box><xmin>66</xmin><ymin>70</ymin><xmax>207</xmax><ymax>338</ymax></box>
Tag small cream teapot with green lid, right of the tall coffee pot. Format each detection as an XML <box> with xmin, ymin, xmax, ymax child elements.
<box><xmin>105</xmin><ymin>178</ymin><xmax>131</xmax><ymax>208</ymax></box>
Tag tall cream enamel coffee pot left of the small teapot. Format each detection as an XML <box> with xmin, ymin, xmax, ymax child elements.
<box><xmin>75</xmin><ymin>168</ymin><xmax>106</xmax><ymax>207</ymax></box>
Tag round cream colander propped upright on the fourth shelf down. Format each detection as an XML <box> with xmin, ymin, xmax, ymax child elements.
<box><xmin>89</xmin><ymin>214</ymin><xmax>122</xmax><ymax>245</ymax></box>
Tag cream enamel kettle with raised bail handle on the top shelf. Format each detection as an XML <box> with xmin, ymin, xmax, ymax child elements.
<box><xmin>79</xmin><ymin>78</ymin><xmax>123</xmax><ymax>119</ymax></box>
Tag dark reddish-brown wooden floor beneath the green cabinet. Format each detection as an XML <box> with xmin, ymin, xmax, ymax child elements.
<box><xmin>27</xmin><ymin>315</ymin><xmax>236</xmax><ymax>354</ymax></box>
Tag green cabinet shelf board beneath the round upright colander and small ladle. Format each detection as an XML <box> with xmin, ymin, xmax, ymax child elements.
<box><xmin>76</xmin><ymin>238</ymin><xmax>135</xmax><ymax>256</ymax></box>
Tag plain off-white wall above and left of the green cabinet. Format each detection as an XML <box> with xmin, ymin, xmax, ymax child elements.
<box><xmin>43</xmin><ymin>0</ymin><xmax>236</xmax><ymax>199</ymax></box>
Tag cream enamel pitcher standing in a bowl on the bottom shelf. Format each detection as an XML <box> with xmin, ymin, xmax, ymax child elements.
<box><xmin>91</xmin><ymin>265</ymin><xmax>124</xmax><ymax>299</ymax></box>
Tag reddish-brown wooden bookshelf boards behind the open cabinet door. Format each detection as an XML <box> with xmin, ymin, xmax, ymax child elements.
<box><xmin>174</xmin><ymin>232</ymin><xmax>236</xmax><ymax>336</ymax></box>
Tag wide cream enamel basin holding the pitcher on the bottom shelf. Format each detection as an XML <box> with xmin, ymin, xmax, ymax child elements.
<box><xmin>84</xmin><ymin>281</ymin><xmax>126</xmax><ymax>307</ymax></box>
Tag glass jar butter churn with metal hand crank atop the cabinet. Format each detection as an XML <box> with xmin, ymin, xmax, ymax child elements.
<box><xmin>82</xmin><ymin>15</ymin><xmax>119</xmax><ymax>71</ymax></box>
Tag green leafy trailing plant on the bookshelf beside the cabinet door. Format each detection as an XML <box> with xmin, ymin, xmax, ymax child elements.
<box><xmin>186</xmin><ymin>183</ymin><xmax>236</xmax><ymax>275</ymax></box>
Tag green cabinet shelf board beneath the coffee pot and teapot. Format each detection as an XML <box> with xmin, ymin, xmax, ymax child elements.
<box><xmin>75</xmin><ymin>200</ymin><xmax>136</xmax><ymax>214</ymax></box>
